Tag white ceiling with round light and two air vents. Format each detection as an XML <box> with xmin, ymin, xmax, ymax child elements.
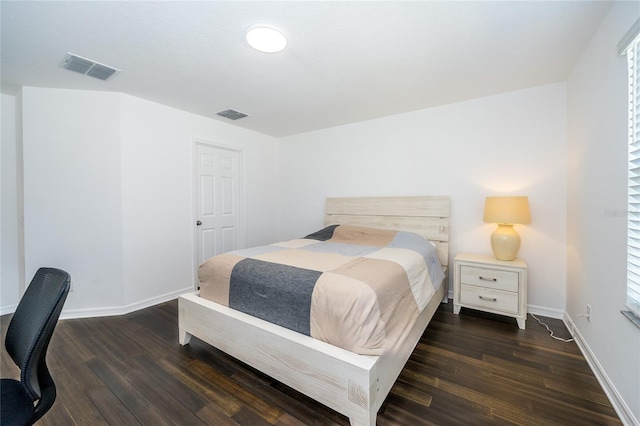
<box><xmin>0</xmin><ymin>0</ymin><xmax>611</xmax><ymax>137</ymax></box>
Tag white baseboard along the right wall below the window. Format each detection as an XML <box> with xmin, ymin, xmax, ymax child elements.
<box><xmin>564</xmin><ymin>312</ymin><xmax>640</xmax><ymax>426</ymax></box>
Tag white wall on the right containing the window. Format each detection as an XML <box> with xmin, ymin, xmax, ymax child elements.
<box><xmin>567</xmin><ymin>2</ymin><xmax>640</xmax><ymax>424</ymax></box>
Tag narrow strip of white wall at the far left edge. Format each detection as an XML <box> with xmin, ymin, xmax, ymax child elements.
<box><xmin>0</xmin><ymin>95</ymin><xmax>20</xmax><ymax>315</ymax></box>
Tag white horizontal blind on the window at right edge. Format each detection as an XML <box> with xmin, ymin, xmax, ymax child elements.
<box><xmin>623</xmin><ymin>27</ymin><xmax>640</xmax><ymax>319</ymax></box>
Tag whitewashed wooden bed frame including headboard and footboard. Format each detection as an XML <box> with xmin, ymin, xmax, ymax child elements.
<box><xmin>178</xmin><ymin>196</ymin><xmax>449</xmax><ymax>426</ymax></box>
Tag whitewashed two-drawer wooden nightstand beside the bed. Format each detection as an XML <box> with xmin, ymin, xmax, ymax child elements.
<box><xmin>453</xmin><ymin>253</ymin><xmax>527</xmax><ymax>330</ymax></box>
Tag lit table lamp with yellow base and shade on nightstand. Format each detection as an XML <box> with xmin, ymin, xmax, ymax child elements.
<box><xmin>482</xmin><ymin>197</ymin><xmax>531</xmax><ymax>260</ymax></box>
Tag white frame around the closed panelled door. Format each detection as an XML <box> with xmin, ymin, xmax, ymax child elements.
<box><xmin>191</xmin><ymin>138</ymin><xmax>247</xmax><ymax>290</ymax></box>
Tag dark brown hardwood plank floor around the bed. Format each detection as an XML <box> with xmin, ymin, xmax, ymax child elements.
<box><xmin>0</xmin><ymin>301</ymin><xmax>620</xmax><ymax>426</ymax></box>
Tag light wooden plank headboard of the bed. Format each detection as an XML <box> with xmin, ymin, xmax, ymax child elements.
<box><xmin>324</xmin><ymin>196</ymin><xmax>449</xmax><ymax>267</ymax></box>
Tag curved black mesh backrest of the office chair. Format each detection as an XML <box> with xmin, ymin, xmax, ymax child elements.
<box><xmin>5</xmin><ymin>268</ymin><xmax>71</xmax><ymax>409</ymax></box>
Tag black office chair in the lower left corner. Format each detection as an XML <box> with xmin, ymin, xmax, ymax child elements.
<box><xmin>0</xmin><ymin>268</ymin><xmax>71</xmax><ymax>426</ymax></box>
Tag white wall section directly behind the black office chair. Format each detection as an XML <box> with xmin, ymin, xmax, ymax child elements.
<box><xmin>22</xmin><ymin>87</ymin><xmax>123</xmax><ymax>311</ymax></box>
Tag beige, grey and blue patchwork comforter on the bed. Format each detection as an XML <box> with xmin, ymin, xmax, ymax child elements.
<box><xmin>199</xmin><ymin>225</ymin><xmax>444</xmax><ymax>355</ymax></box>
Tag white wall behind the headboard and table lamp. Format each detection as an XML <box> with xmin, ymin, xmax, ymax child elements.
<box><xmin>280</xmin><ymin>83</ymin><xmax>567</xmax><ymax>317</ymax></box>
